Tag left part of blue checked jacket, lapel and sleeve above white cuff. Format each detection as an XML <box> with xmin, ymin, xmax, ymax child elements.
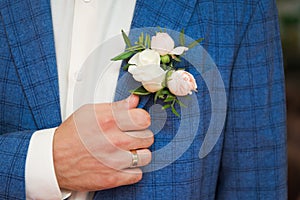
<box><xmin>0</xmin><ymin>0</ymin><xmax>61</xmax><ymax>199</ymax></box>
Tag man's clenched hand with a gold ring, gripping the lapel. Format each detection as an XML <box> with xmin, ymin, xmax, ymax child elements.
<box><xmin>53</xmin><ymin>95</ymin><xmax>153</xmax><ymax>191</ymax></box>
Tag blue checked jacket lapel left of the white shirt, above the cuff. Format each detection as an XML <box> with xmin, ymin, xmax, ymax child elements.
<box><xmin>2</xmin><ymin>0</ymin><xmax>61</xmax><ymax>129</ymax></box>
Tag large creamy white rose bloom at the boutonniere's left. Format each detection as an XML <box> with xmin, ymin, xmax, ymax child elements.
<box><xmin>128</xmin><ymin>49</ymin><xmax>166</xmax><ymax>92</ymax></box>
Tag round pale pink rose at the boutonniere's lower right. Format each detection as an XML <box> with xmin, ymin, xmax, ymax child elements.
<box><xmin>167</xmin><ymin>70</ymin><xmax>197</xmax><ymax>96</ymax></box>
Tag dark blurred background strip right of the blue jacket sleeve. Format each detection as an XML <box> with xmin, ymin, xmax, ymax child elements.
<box><xmin>277</xmin><ymin>0</ymin><xmax>300</xmax><ymax>200</ymax></box>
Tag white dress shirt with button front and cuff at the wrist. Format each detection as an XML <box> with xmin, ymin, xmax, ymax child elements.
<box><xmin>25</xmin><ymin>0</ymin><xmax>135</xmax><ymax>200</ymax></box>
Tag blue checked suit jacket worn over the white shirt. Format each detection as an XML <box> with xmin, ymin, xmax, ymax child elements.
<box><xmin>0</xmin><ymin>0</ymin><xmax>286</xmax><ymax>200</ymax></box>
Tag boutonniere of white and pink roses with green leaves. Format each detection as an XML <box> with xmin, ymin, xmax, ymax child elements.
<box><xmin>111</xmin><ymin>30</ymin><xmax>202</xmax><ymax>116</ymax></box>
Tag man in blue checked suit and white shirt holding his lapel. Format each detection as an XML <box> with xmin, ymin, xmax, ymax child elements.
<box><xmin>0</xmin><ymin>0</ymin><xmax>286</xmax><ymax>199</ymax></box>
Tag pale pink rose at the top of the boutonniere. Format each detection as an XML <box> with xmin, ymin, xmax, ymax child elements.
<box><xmin>151</xmin><ymin>33</ymin><xmax>188</xmax><ymax>56</ymax></box>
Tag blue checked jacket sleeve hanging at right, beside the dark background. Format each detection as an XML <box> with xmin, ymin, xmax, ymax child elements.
<box><xmin>217</xmin><ymin>0</ymin><xmax>287</xmax><ymax>200</ymax></box>
